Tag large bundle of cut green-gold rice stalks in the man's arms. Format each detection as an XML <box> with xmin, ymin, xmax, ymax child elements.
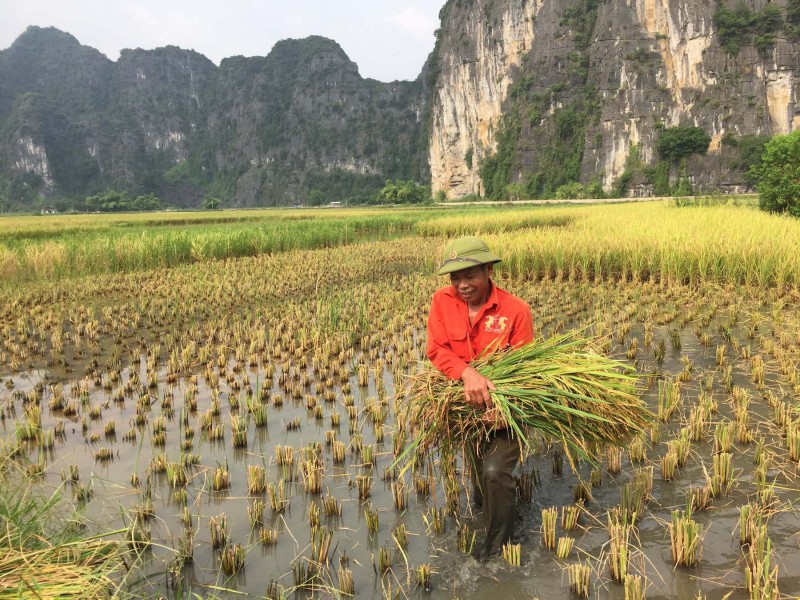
<box><xmin>401</xmin><ymin>332</ymin><xmax>653</xmax><ymax>468</ymax></box>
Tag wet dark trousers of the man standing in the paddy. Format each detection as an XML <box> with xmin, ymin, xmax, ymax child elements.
<box><xmin>472</xmin><ymin>431</ymin><xmax>519</xmax><ymax>554</ymax></box>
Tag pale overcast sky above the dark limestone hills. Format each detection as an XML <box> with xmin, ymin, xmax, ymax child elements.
<box><xmin>0</xmin><ymin>0</ymin><xmax>444</xmax><ymax>81</ymax></box>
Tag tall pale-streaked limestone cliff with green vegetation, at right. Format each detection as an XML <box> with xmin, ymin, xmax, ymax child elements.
<box><xmin>429</xmin><ymin>0</ymin><xmax>800</xmax><ymax>196</ymax></box>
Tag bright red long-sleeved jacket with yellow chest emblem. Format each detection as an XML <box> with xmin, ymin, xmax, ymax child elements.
<box><xmin>427</xmin><ymin>282</ymin><xmax>533</xmax><ymax>379</ymax></box>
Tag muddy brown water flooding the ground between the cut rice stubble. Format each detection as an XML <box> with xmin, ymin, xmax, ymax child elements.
<box><xmin>0</xmin><ymin>288</ymin><xmax>800</xmax><ymax>599</ymax></box>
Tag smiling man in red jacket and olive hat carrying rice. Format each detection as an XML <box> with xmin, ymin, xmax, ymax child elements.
<box><xmin>427</xmin><ymin>236</ymin><xmax>533</xmax><ymax>556</ymax></box>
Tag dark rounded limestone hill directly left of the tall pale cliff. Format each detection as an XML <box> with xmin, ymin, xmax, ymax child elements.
<box><xmin>198</xmin><ymin>37</ymin><xmax>423</xmax><ymax>205</ymax></box>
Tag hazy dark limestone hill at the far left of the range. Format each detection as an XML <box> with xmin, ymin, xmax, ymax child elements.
<box><xmin>0</xmin><ymin>30</ymin><xmax>111</xmax><ymax>206</ymax></box>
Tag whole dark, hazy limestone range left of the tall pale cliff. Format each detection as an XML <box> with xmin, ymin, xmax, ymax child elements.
<box><xmin>0</xmin><ymin>27</ymin><xmax>426</xmax><ymax>207</ymax></box>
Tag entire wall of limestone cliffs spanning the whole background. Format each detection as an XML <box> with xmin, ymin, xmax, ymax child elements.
<box><xmin>0</xmin><ymin>0</ymin><xmax>800</xmax><ymax>206</ymax></box>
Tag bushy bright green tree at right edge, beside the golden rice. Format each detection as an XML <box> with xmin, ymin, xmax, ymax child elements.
<box><xmin>751</xmin><ymin>131</ymin><xmax>800</xmax><ymax>217</ymax></box>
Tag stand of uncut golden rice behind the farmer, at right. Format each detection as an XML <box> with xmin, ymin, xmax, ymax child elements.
<box><xmin>484</xmin><ymin>203</ymin><xmax>800</xmax><ymax>287</ymax></box>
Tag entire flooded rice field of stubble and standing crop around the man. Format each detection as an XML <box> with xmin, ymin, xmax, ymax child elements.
<box><xmin>0</xmin><ymin>203</ymin><xmax>800</xmax><ymax>599</ymax></box>
